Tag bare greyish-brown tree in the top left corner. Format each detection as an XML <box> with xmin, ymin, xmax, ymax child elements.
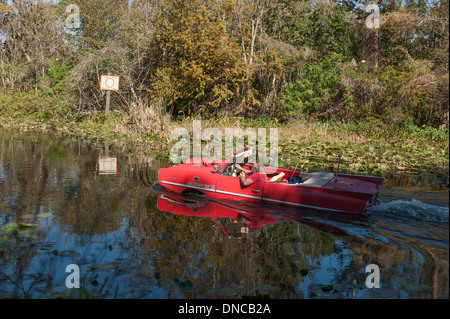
<box><xmin>0</xmin><ymin>0</ymin><xmax>67</xmax><ymax>91</ymax></box>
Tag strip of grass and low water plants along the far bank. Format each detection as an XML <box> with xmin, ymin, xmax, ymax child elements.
<box><xmin>0</xmin><ymin>92</ymin><xmax>449</xmax><ymax>180</ymax></box>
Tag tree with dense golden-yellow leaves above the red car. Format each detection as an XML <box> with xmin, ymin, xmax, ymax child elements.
<box><xmin>153</xmin><ymin>0</ymin><xmax>247</xmax><ymax>115</ymax></box>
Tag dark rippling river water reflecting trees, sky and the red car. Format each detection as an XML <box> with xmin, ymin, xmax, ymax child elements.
<box><xmin>0</xmin><ymin>131</ymin><xmax>449</xmax><ymax>299</ymax></box>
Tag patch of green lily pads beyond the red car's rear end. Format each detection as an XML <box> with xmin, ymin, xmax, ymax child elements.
<box><xmin>279</xmin><ymin>141</ymin><xmax>449</xmax><ymax>176</ymax></box>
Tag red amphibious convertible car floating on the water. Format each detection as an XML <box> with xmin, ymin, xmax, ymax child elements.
<box><xmin>158</xmin><ymin>148</ymin><xmax>384</xmax><ymax>214</ymax></box>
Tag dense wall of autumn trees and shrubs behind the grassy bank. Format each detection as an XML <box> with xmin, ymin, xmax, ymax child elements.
<box><xmin>0</xmin><ymin>0</ymin><xmax>449</xmax><ymax>129</ymax></box>
